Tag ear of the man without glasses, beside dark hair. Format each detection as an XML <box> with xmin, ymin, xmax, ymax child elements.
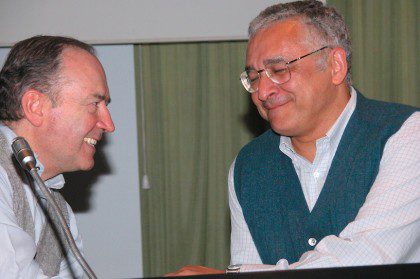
<box><xmin>21</xmin><ymin>89</ymin><xmax>50</xmax><ymax>127</ymax></box>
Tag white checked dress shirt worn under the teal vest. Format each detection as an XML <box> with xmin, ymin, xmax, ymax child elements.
<box><xmin>228</xmin><ymin>89</ymin><xmax>420</xmax><ymax>272</ymax></box>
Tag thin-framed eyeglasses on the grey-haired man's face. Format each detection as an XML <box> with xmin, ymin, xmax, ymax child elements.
<box><xmin>241</xmin><ymin>46</ymin><xmax>329</xmax><ymax>93</ymax></box>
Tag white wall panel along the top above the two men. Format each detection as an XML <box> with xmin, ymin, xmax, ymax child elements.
<box><xmin>0</xmin><ymin>0</ymin><xmax>279</xmax><ymax>46</ymax></box>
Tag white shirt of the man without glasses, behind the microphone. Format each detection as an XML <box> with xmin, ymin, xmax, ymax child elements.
<box><xmin>0</xmin><ymin>124</ymin><xmax>84</xmax><ymax>278</ymax></box>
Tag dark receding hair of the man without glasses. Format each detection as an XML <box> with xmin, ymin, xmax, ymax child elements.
<box><xmin>0</xmin><ymin>36</ymin><xmax>95</xmax><ymax>121</ymax></box>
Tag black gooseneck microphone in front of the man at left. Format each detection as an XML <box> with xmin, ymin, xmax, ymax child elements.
<box><xmin>12</xmin><ymin>137</ymin><xmax>97</xmax><ymax>279</ymax></box>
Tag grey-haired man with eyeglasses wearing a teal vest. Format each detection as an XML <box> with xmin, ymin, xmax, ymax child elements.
<box><xmin>166</xmin><ymin>1</ymin><xmax>420</xmax><ymax>275</ymax></box>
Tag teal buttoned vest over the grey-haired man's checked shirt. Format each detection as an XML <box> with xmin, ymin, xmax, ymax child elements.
<box><xmin>234</xmin><ymin>93</ymin><xmax>416</xmax><ymax>264</ymax></box>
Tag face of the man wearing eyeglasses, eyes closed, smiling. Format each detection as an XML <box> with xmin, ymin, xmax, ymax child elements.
<box><xmin>246</xmin><ymin>19</ymin><xmax>333</xmax><ymax>137</ymax></box>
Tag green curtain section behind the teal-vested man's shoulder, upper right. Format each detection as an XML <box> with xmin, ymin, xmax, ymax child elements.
<box><xmin>327</xmin><ymin>0</ymin><xmax>420</xmax><ymax>107</ymax></box>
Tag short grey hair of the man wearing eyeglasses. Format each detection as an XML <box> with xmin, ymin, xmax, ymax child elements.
<box><xmin>248</xmin><ymin>0</ymin><xmax>351</xmax><ymax>86</ymax></box>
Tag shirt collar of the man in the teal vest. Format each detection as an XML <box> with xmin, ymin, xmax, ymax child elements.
<box><xmin>279</xmin><ymin>87</ymin><xmax>357</xmax><ymax>157</ymax></box>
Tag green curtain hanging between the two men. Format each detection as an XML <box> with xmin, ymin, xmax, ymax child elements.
<box><xmin>135</xmin><ymin>42</ymin><xmax>261</xmax><ymax>276</ymax></box>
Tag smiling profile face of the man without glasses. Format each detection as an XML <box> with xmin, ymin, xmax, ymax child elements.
<box><xmin>36</xmin><ymin>47</ymin><xmax>115</xmax><ymax>174</ymax></box>
